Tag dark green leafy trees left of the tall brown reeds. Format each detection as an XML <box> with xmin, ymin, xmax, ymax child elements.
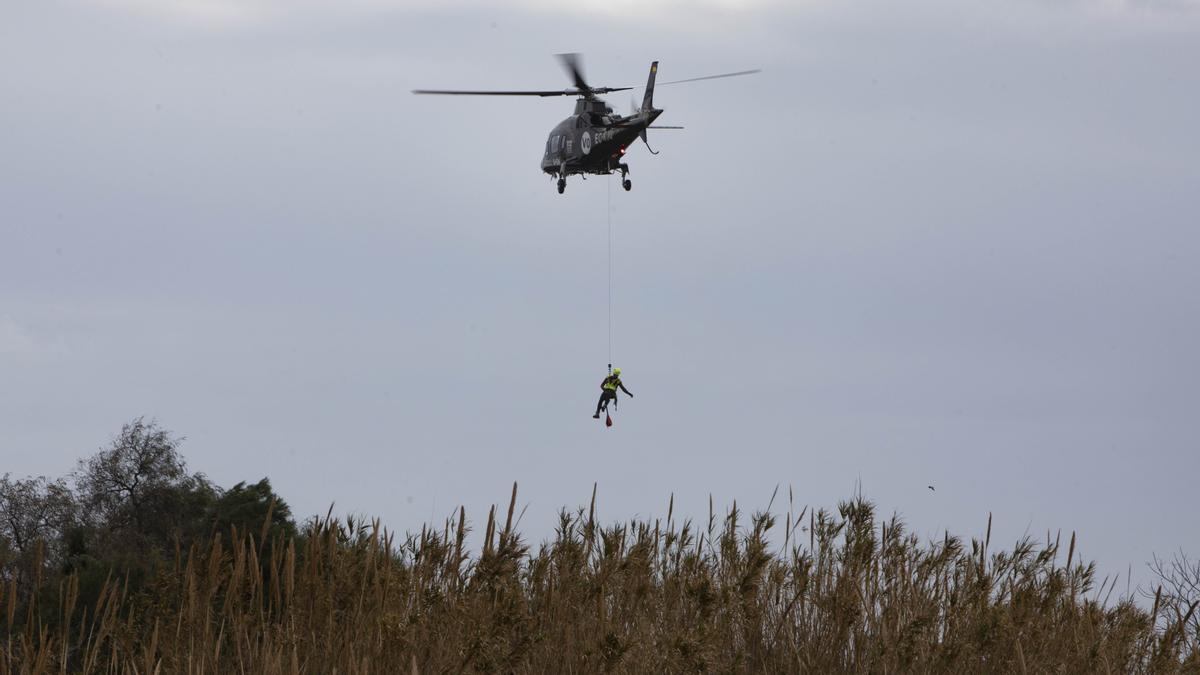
<box><xmin>0</xmin><ymin>418</ymin><xmax>296</xmax><ymax>653</ymax></box>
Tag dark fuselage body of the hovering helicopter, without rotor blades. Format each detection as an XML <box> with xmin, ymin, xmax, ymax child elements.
<box><xmin>541</xmin><ymin>98</ymin><xmax>662</xmax><ymax>177</ymax></box>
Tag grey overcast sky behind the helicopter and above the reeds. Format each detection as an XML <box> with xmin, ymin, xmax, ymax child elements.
<box><xmin>0</xmin><ymin>0</ymin><xmax>1200</xmax><ymax>581</ymax></box>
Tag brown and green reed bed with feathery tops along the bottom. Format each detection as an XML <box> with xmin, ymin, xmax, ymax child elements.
<box><xmin>0</xmin><ymin>485</ymin><xmax>1200</xmax><ymax>674</ymax></box>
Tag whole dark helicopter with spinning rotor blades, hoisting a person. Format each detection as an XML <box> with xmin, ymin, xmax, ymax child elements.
<box><xmin>413</xmin><ymin>54</ymin><xmax>760</xmax><ymax>195</ymax></box>
